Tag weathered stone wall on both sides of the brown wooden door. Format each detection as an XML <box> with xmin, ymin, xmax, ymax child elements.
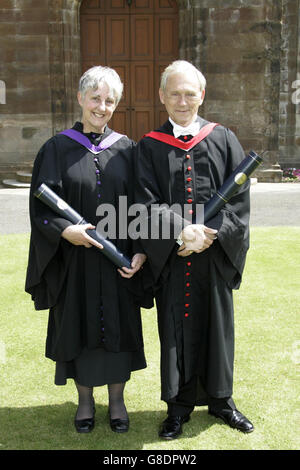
<box><xmin>0</xmin><ymin>0</ymin><xmax>300</xmax><ymax>176</ymax></box>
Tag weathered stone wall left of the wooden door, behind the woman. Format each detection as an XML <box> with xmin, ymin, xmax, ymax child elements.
<box><xmin>0</xmin><ymin>0</ymin><xmax>80</xmax><ymax>173</ymax></box>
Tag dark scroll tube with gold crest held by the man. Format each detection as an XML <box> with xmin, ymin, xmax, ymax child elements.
<box><xmin>202</xmin><ymin>150</ymin><xmax>263</xmax><ymax>223</ymax></box>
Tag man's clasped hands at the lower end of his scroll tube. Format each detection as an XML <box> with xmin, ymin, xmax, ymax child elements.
<box><xmin>180</xmin><ymin>224</ymin><xmax>218</xmax><ymax>256</ymax></box>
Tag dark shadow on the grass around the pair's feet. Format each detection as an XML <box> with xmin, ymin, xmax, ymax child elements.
<box><xmin>0</xmin><ymin>402</ymin><xmax>215</xmax><ymax>450</ymax></box>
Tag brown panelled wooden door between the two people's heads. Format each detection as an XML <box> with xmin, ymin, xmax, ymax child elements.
<box><xmin>80</xmin><ymin>0</ymin><xmax>178</xmax><ymax>140</ymax></box>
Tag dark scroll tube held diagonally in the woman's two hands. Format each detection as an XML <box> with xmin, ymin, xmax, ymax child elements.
<box><xmin>34</xmin><ymin>183</ymin><xmax>131</xmax><ymax>269</ymax></box>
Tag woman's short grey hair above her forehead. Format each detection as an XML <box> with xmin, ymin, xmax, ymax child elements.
<box><xmin>78</xmin><ymin>65</ymin><xmax>123</xmax><ymax>104</ymax></box>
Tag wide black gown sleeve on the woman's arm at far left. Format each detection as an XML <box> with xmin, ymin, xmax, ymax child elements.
<box><xmin>25</xmin><ymin>138</ymin><xmax>72</xmax><ymax>310</ymax></box>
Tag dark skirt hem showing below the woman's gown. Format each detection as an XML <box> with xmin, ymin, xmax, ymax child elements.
<box><xmin>55</xmin><ymin>348</ymin><xmax>147</xmax><ymax>387</ymax></box>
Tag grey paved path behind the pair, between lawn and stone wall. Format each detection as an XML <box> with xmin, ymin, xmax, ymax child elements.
<box><xmin>0</xmin><ymin>183</ymin><xmax>300</xmax><ymax>234</ymax></box>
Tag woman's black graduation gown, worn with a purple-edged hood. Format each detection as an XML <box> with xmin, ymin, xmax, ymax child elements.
<box><xmin>25</xmin><ymin>123</ymin><xmax>147</xmax><ymax>361</ymax></box>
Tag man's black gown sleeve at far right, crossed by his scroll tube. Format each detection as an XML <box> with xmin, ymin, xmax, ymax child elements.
<box><xmin>206</xmin><ymin>130</ymin><xmax>250</xmax><ymax>289</ymax></box>
